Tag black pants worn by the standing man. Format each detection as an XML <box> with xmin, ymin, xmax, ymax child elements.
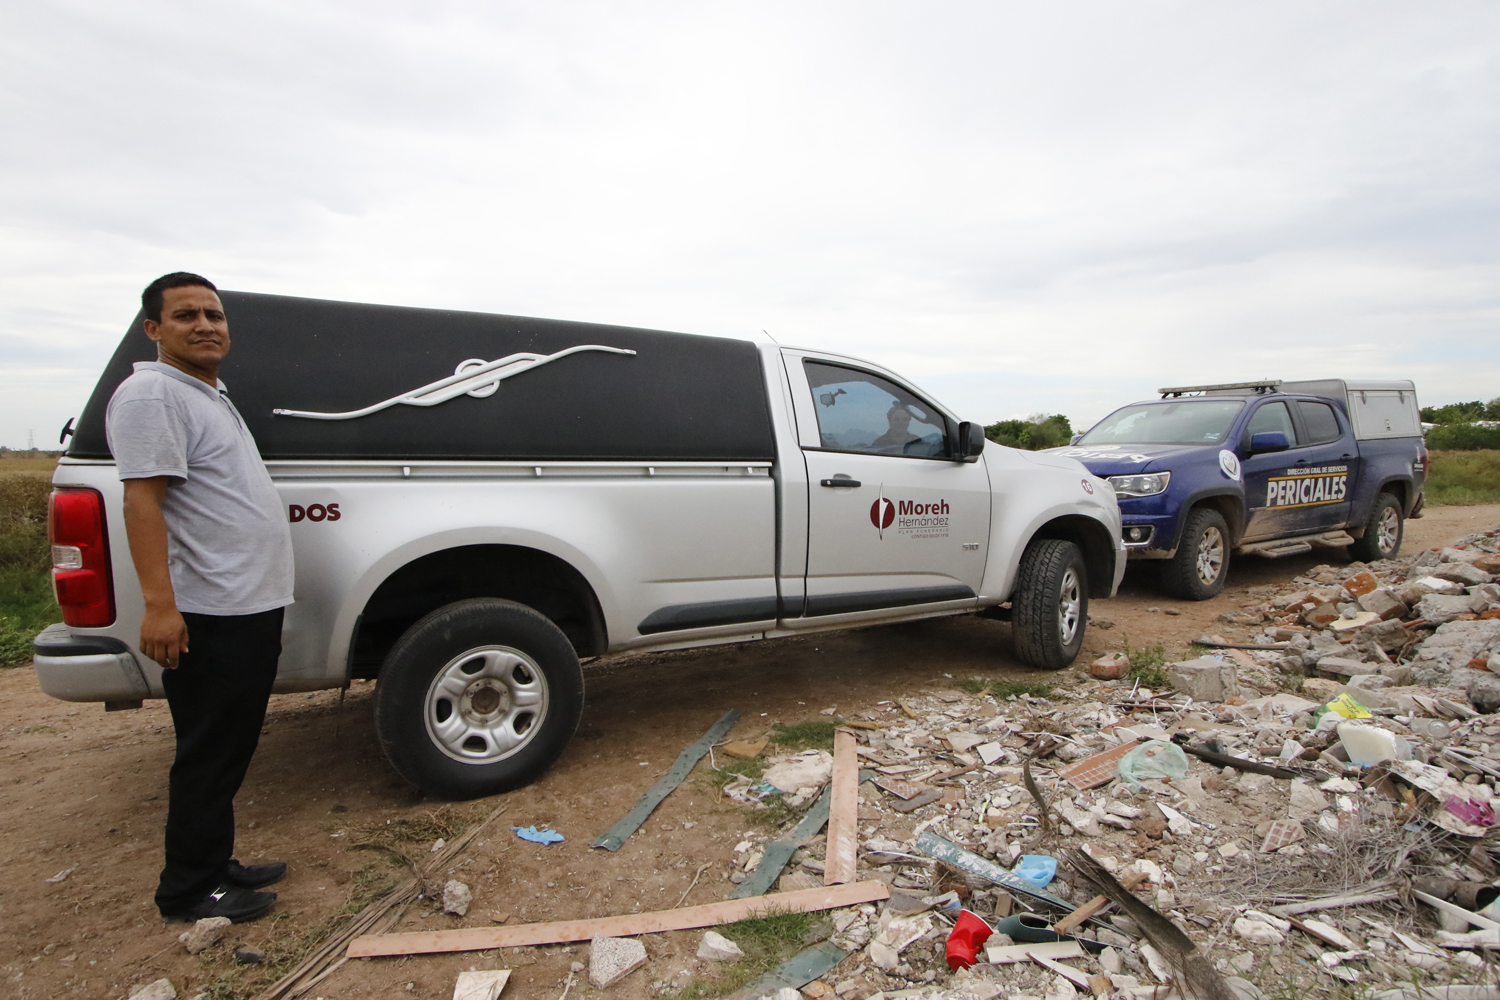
<box><xmin>156</xmin><ymin>607</ymin><xmax>285</xmax><ymax>913</ymax></box>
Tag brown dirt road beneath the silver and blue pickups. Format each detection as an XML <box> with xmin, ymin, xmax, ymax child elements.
<box><xmin>0</xmin><ymin>505</ymin><xmax>1500</xmax><ymax>1000</ymax></box>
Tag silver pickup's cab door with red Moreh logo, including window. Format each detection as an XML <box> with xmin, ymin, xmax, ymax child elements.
<box><xmin>783</xmin><ymin>351</ymin><xmax>990</xmax><ymax>617</ymax></box>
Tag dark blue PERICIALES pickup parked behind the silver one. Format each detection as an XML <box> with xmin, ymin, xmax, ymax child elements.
<box><xmin>1052</xmin><ymin>379</ymin><xmax>1427</xmax><ymax>601</ymax></box>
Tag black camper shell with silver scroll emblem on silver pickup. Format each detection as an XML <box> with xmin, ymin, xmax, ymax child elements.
<box><xmin>68</xmin><ymin>291</ymin><xmax>776</xmax><ymax>463</ymax></box>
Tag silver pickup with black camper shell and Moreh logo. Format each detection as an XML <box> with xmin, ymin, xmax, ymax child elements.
<box><xmin>35</xmin><ymin>292</ymin><xmax>1125</xmax><ymax>798</ymax></box>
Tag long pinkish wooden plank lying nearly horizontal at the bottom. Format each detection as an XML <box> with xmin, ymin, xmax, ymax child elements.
<box><xmin>348</xmin><ymin>882</ymin><xmax>891</xmax><ymax>958</ymax></box>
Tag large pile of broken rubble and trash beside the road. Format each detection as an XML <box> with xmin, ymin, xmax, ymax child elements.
<box><xmin>705</xmin><ymin>531</ymin><xmax>1500</xmax><ymax>1000</ymax></box>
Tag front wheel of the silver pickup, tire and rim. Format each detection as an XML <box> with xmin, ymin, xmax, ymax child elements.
<box><xmin>1011</xmin><ymin>538</ymin><xmax>1089</xmax><ymax>670</ymax></box>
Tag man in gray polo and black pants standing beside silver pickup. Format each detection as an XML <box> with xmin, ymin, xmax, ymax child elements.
<box><xmin>105</xmin><ymin>271</ymin><xmax>293</xmax><ymax>922</ymax></box>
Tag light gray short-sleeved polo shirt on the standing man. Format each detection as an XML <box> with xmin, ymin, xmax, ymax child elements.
<box><xmin>105</xmin><ymin>361</ymin><xmax>293</xmax><ymax>615</ymax></box>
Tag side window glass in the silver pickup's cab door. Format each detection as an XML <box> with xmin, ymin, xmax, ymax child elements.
<box><xmin>804</xmin><ymin>361</ymin><xmax>948</xmax><ymax>459</ymax></box>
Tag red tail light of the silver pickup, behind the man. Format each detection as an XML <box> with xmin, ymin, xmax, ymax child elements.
<box><xmin>47</xmin><ymin>489</ymin><xmax>114</xmax><ymax>628</ymax></box>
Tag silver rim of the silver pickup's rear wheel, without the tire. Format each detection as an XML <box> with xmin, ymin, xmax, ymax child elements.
<box><xmin>422</xmin><ymin>646</ymin><xmax>548</xmax><ymax>763</ymax></box>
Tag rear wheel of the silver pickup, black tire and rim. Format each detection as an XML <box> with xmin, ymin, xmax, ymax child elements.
<box><xmin>375</xmin><ymin>598</ymin><xmax>584</xmax><ymax>799</ymax></box>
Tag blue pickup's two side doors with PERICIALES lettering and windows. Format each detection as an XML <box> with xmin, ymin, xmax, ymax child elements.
<box><xmin>1244</xmin><ymin>399</ymin><xmax>1355</xmax><ymax>541</ymax></box>
